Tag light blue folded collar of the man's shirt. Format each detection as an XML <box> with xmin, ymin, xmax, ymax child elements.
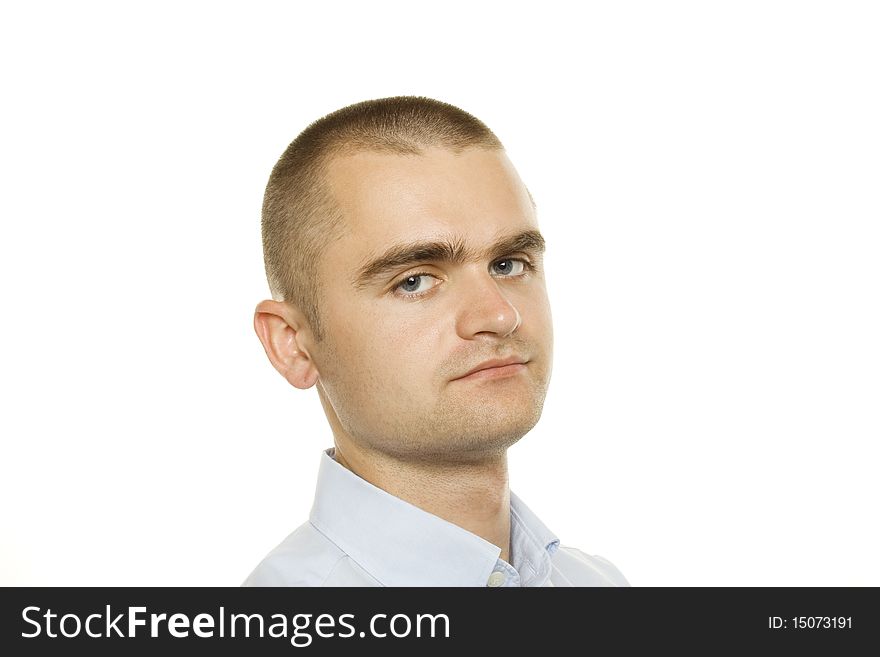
<box><xmin>309</xmin><ymin>447</ymin><xmax>559</xmax><ymax>586</ymax></box>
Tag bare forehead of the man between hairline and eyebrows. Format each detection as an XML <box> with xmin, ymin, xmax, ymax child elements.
<box><xmin>327</xmin><ymin>147</ymin><xmax>537</xmax><ymax>246</ymax></box>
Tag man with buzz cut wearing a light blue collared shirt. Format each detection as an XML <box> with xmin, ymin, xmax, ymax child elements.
<box><xmin>244</xmin><ymin>96</ymin><xmax>628</xmax><ymax>586</ymax></box>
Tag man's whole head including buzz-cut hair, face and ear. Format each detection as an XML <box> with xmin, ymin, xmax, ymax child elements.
<box><xmin>254</xmin><ymin>97</ymin><xmax>553</xmax><ymax>463</ymax></box>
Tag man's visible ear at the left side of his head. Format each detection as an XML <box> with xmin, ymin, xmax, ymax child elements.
<box><xmin>254</xmin><ymin>300</ymin><xmax>319</xmax><ymax>390</ymax></box>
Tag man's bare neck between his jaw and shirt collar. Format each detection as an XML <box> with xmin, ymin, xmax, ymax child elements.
<box><xmin>335</xmin><ymin>440</ymin><xmax>510</xmax><ymax>562</ymax></box>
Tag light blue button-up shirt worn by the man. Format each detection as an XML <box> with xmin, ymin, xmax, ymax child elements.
<box><xmin>243</xmin><ymin>447</ymin><xmax>629</xmax><ymax>586</ymax></box>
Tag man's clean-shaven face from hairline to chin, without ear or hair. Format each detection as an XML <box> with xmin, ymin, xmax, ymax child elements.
<box><xmin>309</xmin><ymin>148</ymin><xmax>553</xmax><ymax>464</ymax></box>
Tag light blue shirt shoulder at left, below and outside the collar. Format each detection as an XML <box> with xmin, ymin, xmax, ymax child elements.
<box><xmin>242</xmin><ymin>522</ymin><xmax>347</xmax><ymax>586</ymax></box>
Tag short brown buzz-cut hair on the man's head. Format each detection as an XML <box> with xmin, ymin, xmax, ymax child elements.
<box><xmin>262</xmin><ymin>96</ymin><xmax>508</xmax><ymax>341</ymax></box>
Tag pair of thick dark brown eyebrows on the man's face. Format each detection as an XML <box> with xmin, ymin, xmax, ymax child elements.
<box><xmin>352</xmin><ymin>230</ymin><xmax>545</xmax><ymax>290</ymax></box>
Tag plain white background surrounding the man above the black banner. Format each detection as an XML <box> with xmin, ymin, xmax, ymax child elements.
<box><xmin>0</xmin><ymin>1</ymin><xmax>880</xmax><ymax>586</ymax></box>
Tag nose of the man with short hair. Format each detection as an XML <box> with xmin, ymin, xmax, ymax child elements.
<box><xmin>456</xmin><ymin>272</ymin><xmax>522</xmax><ymax>340</ymax></box>
